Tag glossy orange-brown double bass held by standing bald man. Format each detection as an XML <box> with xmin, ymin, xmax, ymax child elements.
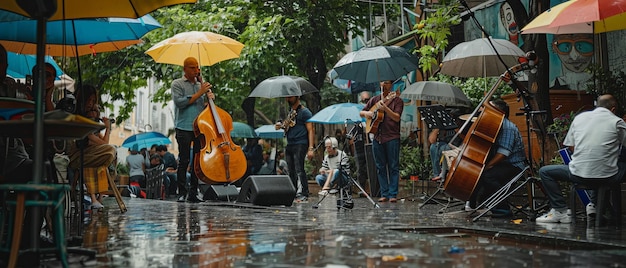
<box><xmin>193</xmin><ymin>78</ymin><xmax>247</xmax><ymax>184</ymax></box>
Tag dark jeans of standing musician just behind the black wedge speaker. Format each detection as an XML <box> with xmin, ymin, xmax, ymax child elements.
<box><xmin>285</xmin><ymin>144</ymin><xmax>309</xmax><ymax>196</ymax></box>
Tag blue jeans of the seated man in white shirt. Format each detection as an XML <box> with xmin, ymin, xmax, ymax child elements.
<box><xmin>539</xmin><ymin>165</ymin><xmax>623</xmax><ymax>210</ymax></box>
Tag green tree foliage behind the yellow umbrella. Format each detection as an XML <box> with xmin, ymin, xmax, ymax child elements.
<box><xmin>59</xmin><ymin>0</ymin><xmax>369</xmax><ymax>127</ymax></box>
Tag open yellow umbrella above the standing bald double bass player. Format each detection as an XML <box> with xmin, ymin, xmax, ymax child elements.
<box><xmin>146</xmin><ymin>31</ymin><xmax>243</xmax><ymax>66</ymax></box>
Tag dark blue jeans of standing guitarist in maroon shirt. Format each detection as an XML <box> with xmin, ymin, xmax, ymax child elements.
<box><xmin>372</xmin><ymin>139</ymin><xmax>400</xmax><ymax>198</ymax></box>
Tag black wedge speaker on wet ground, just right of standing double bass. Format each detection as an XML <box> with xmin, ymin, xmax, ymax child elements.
<box><xmin>237</xmin><ymin>175</ymin><xmax>296</xmax><ymax>207</ymax></box>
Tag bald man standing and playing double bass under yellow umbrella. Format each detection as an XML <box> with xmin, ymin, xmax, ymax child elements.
<box><xmin>172</xmin><ymin>57</ymin><xmax>215</xmax><ymax>203</ymax></box>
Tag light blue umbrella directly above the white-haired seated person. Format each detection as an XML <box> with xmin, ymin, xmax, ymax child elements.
<box><xmin>308</xmin><ymin>103</ymin><xmax>365</xmax><ymax>124</ymax></box>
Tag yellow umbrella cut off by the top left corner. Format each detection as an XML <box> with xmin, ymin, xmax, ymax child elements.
<box><xmin>0</xmin><ymin>0</ymin><xmax>197</xmax><ymax>20</ymax></box>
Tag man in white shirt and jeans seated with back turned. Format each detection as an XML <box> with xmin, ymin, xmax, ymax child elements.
<box><xmin>536</xmin><ymin>94</ymin><xmax>626</xmax><ymax>223</ymax></box>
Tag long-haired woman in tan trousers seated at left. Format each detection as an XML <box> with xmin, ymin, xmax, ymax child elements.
<box><xmin>69</xmin><ymin>85</ymin><xmax>116</xmax><ymax>209</ymax></box>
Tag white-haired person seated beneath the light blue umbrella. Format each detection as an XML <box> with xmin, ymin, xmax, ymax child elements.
<box><xmin>315</xmin><ymin>137</ymin><xmax>350</xmax><ymax>195</ymax></box>
